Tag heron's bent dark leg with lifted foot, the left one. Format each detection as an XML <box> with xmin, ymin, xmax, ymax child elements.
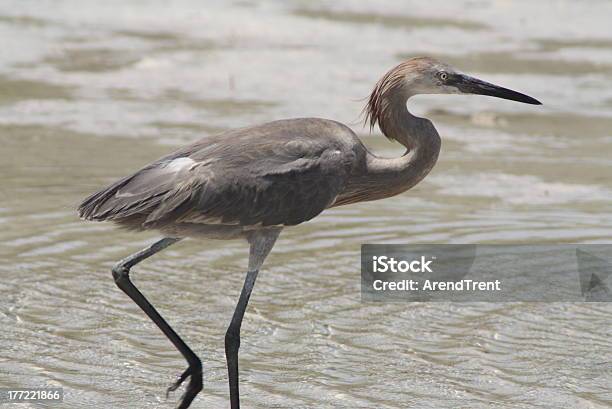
<box><xmin>113</xmin><ymin>238</ymin><xmax>202</xmax><ymax>409</ymax></box>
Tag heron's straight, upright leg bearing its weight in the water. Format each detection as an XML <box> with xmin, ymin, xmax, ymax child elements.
<box><xmin>225</xmin><ymin>229</ymin><xmax>280</xmax><ymax>409</ymax></box>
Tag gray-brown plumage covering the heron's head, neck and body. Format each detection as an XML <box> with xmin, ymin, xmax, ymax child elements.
<box><xmin>79</xmin><ymin>58</ymin><xmax>531</xmax><ymax>237</ymax></box>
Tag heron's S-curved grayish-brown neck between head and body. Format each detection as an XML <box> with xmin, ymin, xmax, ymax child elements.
<box><xmin>360</xmin><ymin>95</ymin><xmax>441</xmax><ymax>198</ymax></box>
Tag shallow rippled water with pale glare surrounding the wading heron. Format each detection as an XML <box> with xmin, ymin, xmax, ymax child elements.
<box><xmin>0</xmin><ymin>0</ymin><xmax>612</xmax><ymax>409</ymax></box>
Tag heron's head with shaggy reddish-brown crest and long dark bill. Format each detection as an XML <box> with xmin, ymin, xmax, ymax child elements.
<box><xmin>365</xmin><ymin>57</ymin><xmax>542</xmax><ymax>131</ymax></box>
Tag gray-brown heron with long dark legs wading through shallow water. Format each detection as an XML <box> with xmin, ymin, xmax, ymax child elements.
<box><xmin>78</xmin><ymin>57</ymin><xmax>541</xmax><ymax>409</ymax></box>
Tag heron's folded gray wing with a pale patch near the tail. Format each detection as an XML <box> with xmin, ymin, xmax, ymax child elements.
<box><xmin>79</xmin><ymin>120</ymin><xmax>354</xmax><ymax>228</ymax></box>
